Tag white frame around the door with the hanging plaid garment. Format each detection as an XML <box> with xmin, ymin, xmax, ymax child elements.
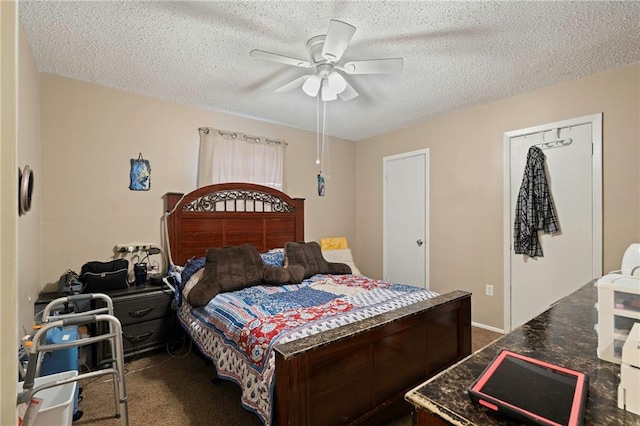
<box><xmin>503</xmin><ymin>113</ymin><xmax>602</xmax><ymax>332</ymax></box>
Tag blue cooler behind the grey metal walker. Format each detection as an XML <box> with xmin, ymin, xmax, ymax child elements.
<box><xmin>40</xmin><ymin>325</ymin><xmax>80</xmax><ymax>419</ymax></box>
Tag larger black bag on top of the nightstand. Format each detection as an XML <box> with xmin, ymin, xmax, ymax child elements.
<box><xmin>80</xmin><ymin>259</ymin><xmax>129</xmax><ymax>293</ymax></box>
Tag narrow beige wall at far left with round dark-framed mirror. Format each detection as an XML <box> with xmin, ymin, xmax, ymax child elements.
<box><xmin>17</xmin><ymin>26</ymin><xmax>44</xmax><ymax>336</ymax></box>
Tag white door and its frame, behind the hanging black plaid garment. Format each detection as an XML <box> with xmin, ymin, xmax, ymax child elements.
<box><xmin>505</xmin><ymin>114</ymin><xmax>602</xmax><ymax>331</ymax></box>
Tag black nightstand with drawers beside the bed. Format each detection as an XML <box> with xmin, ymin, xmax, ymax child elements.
<box><xmin>96</xmin><ymin>284</ymin><xmax>181</xmax><ymax>366</ymax></box>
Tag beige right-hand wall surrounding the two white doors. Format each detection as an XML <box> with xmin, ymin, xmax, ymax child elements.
<box><xmin>356</xmin><ymin>64</ymin><xmax>640</xmax><ymax>329</ymax></box>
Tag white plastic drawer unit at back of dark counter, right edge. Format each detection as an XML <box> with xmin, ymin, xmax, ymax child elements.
<box><xmin>596</xmin><ymin>274</ymin><xmax>640</xmax><ymax>364</ymax></box>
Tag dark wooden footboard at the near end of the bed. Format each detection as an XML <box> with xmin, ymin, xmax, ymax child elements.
<box><xmin>274</xmin><ymin>291</ymin><xmax>471</xmax><ymax>426</ymax></box>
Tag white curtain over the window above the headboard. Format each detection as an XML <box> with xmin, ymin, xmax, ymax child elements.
<box><xmin>197</xmin><ymin>128</ymin><xmax>285</xmax><ymax>191</ymax></box>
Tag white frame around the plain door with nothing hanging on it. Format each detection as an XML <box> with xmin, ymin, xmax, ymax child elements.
<box><xmin>382</xmin><ymin>148</ymin><xmax>430</xmax><ymax>288</ymax></box>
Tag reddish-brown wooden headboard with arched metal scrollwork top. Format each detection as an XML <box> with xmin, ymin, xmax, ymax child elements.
<box><xmin>164</xmin><ymin>183</ymin><xmax>304</xmax><ymax>265</ymax></box>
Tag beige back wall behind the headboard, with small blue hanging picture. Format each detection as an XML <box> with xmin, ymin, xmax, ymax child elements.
<box><xmin>40</xmin><ymin>74</ymin><xmax>355</xmax><ymax>282</ymax></box>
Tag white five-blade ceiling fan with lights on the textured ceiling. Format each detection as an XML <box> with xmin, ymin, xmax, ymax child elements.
<box><xmin>249</xmin><ymin>19</ymin><xmax>403</xmax><ymax>102</ymax></box>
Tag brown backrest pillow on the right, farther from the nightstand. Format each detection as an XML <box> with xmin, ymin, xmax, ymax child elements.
<box><xmin>284</xmin><ymin>241</ymin><xmax>351</xmax><ymax>279</ymax></box>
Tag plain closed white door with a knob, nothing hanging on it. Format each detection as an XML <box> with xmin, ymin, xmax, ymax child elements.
<box><xmin>383</xmin><ymin>149</ymin><xmax>429</xmax><ymax>288</ymax></box>
